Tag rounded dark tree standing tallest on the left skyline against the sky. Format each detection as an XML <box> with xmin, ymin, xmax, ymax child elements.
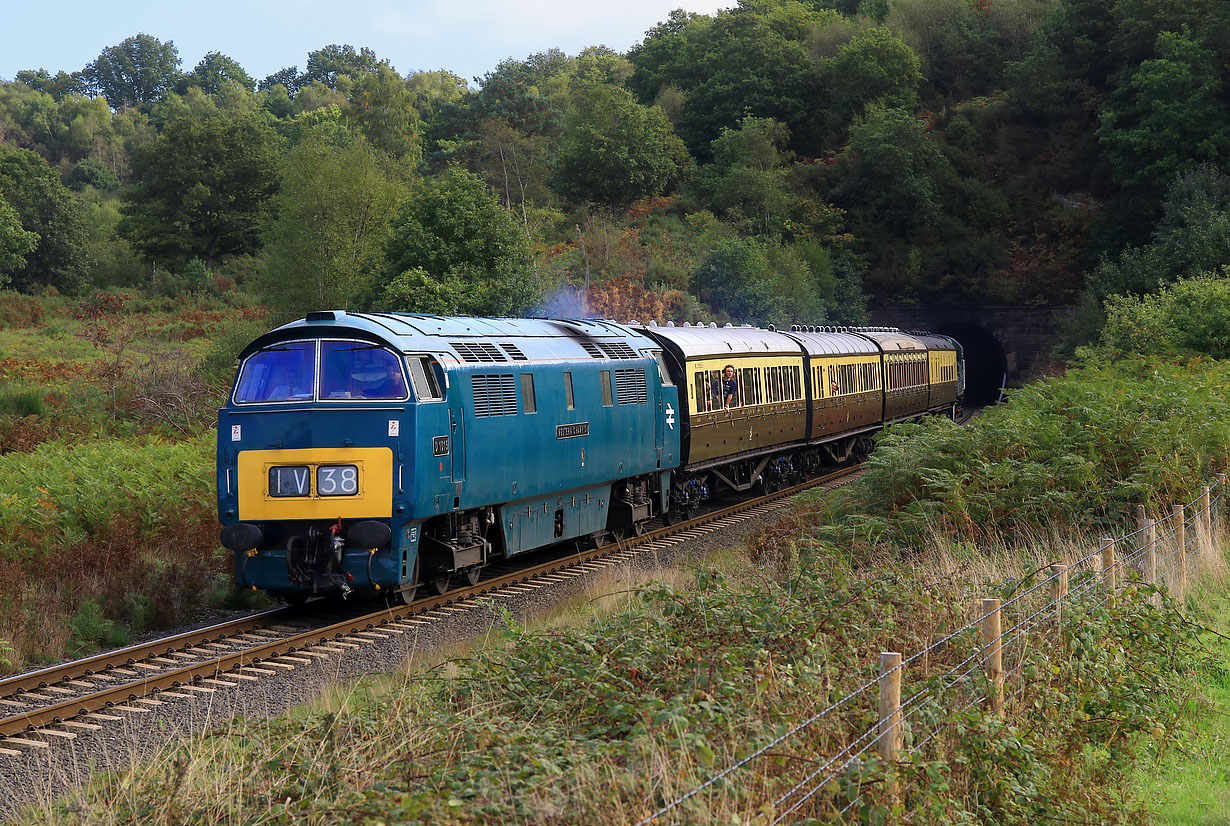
<box><xmin>81</xmin><ymin>33</ymin><xmax>180</xmax><ymax>109</ymax></box>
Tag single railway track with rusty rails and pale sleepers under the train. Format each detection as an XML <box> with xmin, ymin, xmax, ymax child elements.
<box><xmin>0</xmin><ymin>467</ymin><xmax>859</xmax><ymax>757</ymax></box>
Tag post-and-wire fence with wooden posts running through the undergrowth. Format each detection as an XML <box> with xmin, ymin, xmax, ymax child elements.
<box><xmin>636</xmin><ymin>473</ymin><xmax>1226</xmax><ymax>826</ymax></box>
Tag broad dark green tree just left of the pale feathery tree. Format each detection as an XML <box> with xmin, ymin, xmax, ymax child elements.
<box><xmin>119</xmin><ymin>111</ymin><xmax>282</xmax><ymax>264</ymax></box>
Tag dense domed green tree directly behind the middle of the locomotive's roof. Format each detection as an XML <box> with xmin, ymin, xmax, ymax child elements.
<box><xmin>383</xmin><ymin>168</ymin><xmax>540</xmax><ymax>316</ymax></box>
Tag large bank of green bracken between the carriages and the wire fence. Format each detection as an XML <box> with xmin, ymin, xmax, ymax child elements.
<box><xmin>812</xmin><ymin>358</ymin><xmax>1230</xmax><ymax>548</ymax></box>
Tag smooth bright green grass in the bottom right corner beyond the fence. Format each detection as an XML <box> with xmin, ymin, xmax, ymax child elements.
<box><xmin>1138</xmin><ymin>584</ymin><xmax>1230</xmax><ymax>826</ymax></box>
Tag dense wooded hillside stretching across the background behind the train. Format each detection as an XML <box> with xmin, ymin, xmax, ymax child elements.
<box><xmin>0</xmin><ymin>0</ymin><xmax>1230</xmax><ymax>340</ymax></box>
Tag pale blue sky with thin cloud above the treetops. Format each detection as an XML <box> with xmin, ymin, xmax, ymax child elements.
<box><xmin>0</xmin><ymin>0</ymin><xmax>734</xmax><ymax>85</ymax></box>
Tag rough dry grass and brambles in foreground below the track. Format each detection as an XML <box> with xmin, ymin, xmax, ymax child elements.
<box><xmin>18</xmin><ymin>508</ymin><xmax>1210</xmax><ymax>826</ymax></box>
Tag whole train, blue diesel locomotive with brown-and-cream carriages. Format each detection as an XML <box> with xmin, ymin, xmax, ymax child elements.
<box><xmin>218</xmin><ymin>311</ymin><xmax>962</xmax><ymax>602</ymax></box>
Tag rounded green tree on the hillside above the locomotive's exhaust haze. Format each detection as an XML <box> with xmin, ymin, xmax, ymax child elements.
<box><xmin>555</xmin><ymin>84</ymin><xmax>689</xmax><ymax>208</ymax></box>
